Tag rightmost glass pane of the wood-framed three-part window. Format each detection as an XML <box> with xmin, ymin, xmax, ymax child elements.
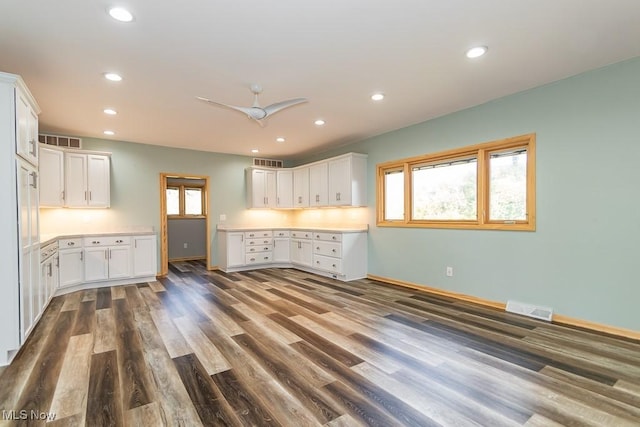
<box><xmin>489</xmin><ymin>150</ymin><xmax>527</xmax><ymax>221</ymax></box>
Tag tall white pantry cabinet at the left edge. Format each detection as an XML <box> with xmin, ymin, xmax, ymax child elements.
<box><xmin>0</xmin><ymin>73</ymin><xmax>41</xmax><ymax>365</ymax></box>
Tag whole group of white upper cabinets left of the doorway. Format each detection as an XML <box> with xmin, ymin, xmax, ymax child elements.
<box><xmin>40</xmin><ymin>144</ymin><xmax>111</xmax><ymax>208</ymax></box>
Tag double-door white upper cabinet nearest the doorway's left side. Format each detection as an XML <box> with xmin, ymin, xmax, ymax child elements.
<box><xmin>64</xmin><ymin>152</ymin><xmax>111</xmax><ymax>208</ymax></box>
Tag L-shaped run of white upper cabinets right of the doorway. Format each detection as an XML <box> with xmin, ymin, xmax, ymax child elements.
<box><xmin>246</xmin><ymin>153</ymin><xmax>367</xmax><ymax>208</ymax></box>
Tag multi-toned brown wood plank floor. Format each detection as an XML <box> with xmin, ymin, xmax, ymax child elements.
<box><xmin>0</xmin><ymin>262</ymin><xmax>640</xmax><ymax>427</ymax></box>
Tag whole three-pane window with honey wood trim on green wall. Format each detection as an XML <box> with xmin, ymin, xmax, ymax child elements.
<box><xmin>376</xmin><ymin>134</ymin><xmax>535</xmax><ymax>231</ymax></box>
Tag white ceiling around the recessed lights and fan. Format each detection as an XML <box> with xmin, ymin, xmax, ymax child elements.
<box><xmin>0</xmin><ymin>0</ymin><xmax>640</xmax><ymax>159</ymax></box>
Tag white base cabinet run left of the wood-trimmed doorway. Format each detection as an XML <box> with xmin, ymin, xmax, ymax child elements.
<box><xmin>58</xmin><ymin>233</ymin><xmax>157</xmax><ymax>294</ymax></box>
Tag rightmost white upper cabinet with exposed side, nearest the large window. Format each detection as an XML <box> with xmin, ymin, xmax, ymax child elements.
<box><xmin>329</xmin><ymin>153</ymin><xmax>367</xmax><ymax>206</ymax></box>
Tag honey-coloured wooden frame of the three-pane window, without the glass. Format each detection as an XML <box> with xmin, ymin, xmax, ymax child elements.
<box><xmin>376</xmin><ymin>133</ymin><xmax>536</xmax><ymax>231</ymax></box>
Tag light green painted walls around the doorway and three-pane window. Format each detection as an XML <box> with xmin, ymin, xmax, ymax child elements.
<box><xmin>84</xmin><ymin>59</ymin><xmax>640</xmax><ymax>330</ymax></box>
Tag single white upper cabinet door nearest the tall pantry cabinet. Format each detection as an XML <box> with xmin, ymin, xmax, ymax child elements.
<box><xmin>39</xmin><ymin>147</ymin><xmax>64</xmax><ymax>208</ymax></box>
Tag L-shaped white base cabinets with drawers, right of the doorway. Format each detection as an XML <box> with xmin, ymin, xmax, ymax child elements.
<box><xmin>218</xmin><ymin>229</ymin><xmax>367</xmax><ymax>281</ymax></box>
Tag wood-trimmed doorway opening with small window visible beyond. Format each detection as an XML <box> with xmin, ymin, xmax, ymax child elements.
<box><xmin>160</xmin><ymin>173</ymin><xmax>211</xmax><ymax>276</ymax></box>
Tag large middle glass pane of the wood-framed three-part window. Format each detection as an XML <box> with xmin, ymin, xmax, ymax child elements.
<box><xmin>412</xmin><ymin>158</ymin><xmax>478</xmax><ymax>220</ymax></box>
